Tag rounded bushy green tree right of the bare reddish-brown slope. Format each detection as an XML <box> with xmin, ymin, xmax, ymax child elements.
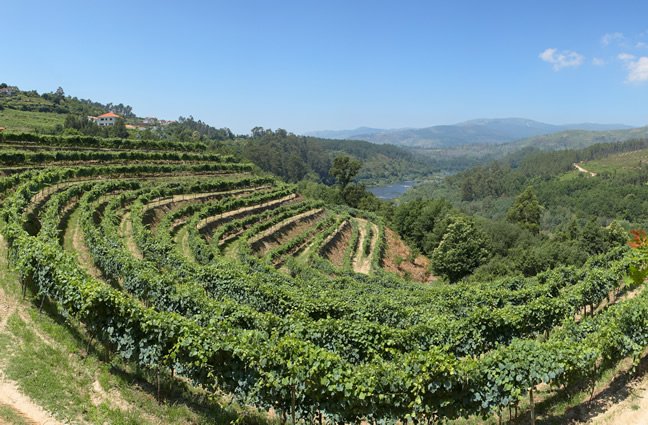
<box><xmin>432</xmin><ymin>216</ymin><xmax>489</xmax><ymax>282</ymax></box>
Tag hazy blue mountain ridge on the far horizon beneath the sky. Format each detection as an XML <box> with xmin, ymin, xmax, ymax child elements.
<box><xmin>306</xmin><ymin>118</ymin><xmax>633</xmax><ymax>148</ymax></box>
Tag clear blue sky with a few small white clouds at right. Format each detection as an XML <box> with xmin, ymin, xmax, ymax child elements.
<box><xmin>0</xmin><ymin>0</ymin><xmax>648</xmax><ymax>133</ymax></box>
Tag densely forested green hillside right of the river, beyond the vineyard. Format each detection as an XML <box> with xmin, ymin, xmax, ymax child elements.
<box><xmin>394</xmin><ymin>139</ymin><xmax>648</xmax><ymax>277</ymax></box>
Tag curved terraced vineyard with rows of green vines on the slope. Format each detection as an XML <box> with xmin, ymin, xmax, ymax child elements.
<box><xmin>0</xmin><ymin>131</ymin><xmax>648</xmax><ymax>423</ymax></box>
